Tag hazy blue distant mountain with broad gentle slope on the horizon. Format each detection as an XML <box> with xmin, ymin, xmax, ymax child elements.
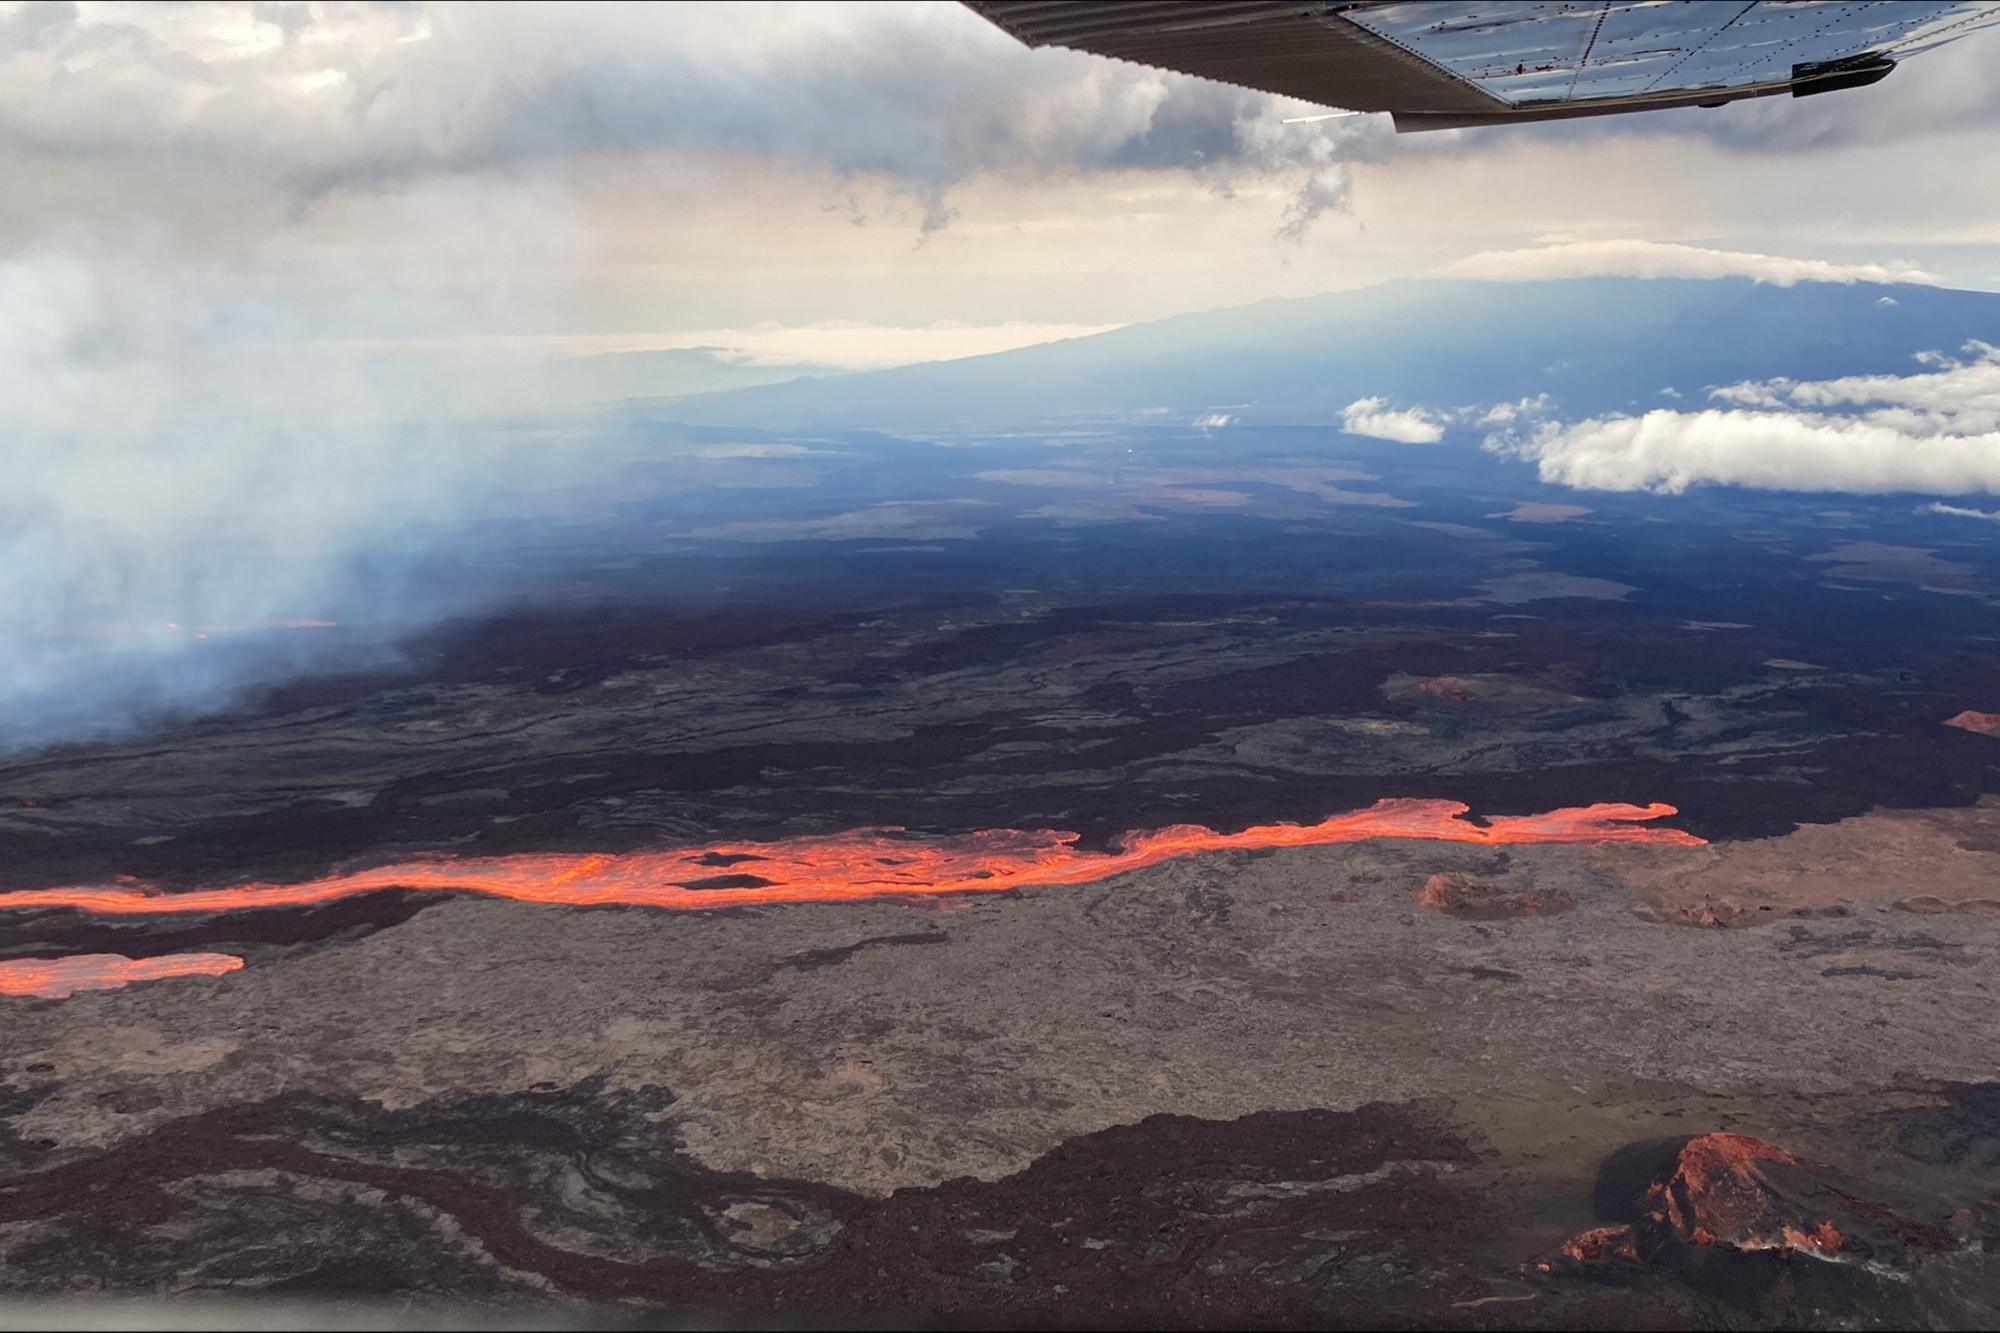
<box><xmin>668</xmin><ymin>278</ymin><xmax>2000</xmax><ymax>428</ymax></box>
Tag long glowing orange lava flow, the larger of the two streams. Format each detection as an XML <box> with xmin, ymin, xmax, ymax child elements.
<box><xmin>0</xmin><ymin>801</ymin><xmax>1702</xmax><ymax>915</ymax></box>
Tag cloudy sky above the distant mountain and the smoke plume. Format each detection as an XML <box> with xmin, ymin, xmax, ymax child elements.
<box><xmin>11</xmin><ymin>2</ymin><xmax>2000</xmax><ymax>366</ymax></box>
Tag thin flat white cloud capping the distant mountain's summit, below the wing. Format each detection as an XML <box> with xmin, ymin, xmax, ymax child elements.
<box><xmin>1440</xmin><ymin>240</ymin><xmax>1938</xmax><ymax>286</ymax></box>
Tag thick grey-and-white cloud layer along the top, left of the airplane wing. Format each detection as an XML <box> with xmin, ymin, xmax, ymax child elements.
<box><xmin>0</xmin><ymin>2</ymin><xmax>1386</xmax><ymax>230</ymax></box>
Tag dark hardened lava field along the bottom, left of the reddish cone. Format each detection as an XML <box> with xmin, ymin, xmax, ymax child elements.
<box><xmin>0</xmin><ymin>1081</ymin><xmax>1512</xmax><ymax>1327</ymax></box>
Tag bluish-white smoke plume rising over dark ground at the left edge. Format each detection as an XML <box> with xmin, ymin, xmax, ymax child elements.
<box><xmin>0</xmin><ymin>228</ymin><xmax>608</xmax><ymax>749</ymax></box>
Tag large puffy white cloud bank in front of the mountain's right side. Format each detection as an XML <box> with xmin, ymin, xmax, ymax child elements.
<box><xmin>1488</xmin><ymin>342</ymin><xmax>2000</xmax><ymax>492</ymax></box>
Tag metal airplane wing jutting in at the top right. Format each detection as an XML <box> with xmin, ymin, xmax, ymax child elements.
<box><xmin>966</xmin><ymin>0</ymin><xmax>2000</xmax><ymax>130</ymax></box>
